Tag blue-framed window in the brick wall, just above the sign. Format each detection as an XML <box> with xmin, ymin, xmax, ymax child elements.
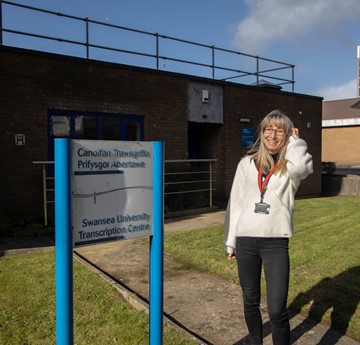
<box><xmin>48</xmin><ymin>110</ymin><xmax>144</xmax><ymax>161</ymax></box>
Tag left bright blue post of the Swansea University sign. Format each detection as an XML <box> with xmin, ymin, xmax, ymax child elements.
<box><xmin>55</xmin><ymin>139</ymin><xmax>74</xmax><ymax>345</ymax></box>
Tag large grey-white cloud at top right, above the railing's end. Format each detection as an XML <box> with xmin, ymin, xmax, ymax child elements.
<box><xmin>232</xmin><ymin>0</ymin><xmax>360</xmax><ymax>54</ymax></box>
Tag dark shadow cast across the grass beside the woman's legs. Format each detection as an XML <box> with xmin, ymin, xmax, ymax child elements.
<box><xmin>233</xmin><ymin>266</ymin><xmax>360</xmax><ymax>345</ymax></box>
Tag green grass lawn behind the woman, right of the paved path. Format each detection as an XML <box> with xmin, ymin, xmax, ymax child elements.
<box><xmin>165</xmin><ymin>197</ymin><xmax>360</xmax><ymax>341</ymax></box>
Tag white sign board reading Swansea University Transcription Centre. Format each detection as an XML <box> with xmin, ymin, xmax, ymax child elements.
<box><xmin>72</xmin><ymin>140</ymin><xmax>153</xmax><ymax>246</ymax></box>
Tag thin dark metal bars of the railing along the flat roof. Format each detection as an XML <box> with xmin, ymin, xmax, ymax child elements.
<box><xmin>0</xmin><ymin>0</ymin><xmax>295</xmax><ymax>92</ymax></box>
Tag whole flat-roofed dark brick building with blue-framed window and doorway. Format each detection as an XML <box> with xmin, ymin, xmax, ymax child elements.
<box><xmin>0</xmin><ymin>46</ymin><xmax>322</xmax><ymax>218</ymax></box>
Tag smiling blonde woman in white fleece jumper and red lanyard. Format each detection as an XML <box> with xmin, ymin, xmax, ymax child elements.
<box><xmin>225</xmin><ymin>110</ymin><xmax>313</xmax><ymax>345</ymax></box>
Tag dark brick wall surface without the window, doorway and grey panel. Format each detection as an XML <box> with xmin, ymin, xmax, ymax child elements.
<box><xmin>0</xmin><ymin>47</ymin><xmax>322</xmax><ymax>217</ymax></box>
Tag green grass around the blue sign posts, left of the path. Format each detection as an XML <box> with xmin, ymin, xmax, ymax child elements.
<box><xmin>0</xmin><ymin>250</ymin><xmax>194</xmax><ymax>345</ymax></box>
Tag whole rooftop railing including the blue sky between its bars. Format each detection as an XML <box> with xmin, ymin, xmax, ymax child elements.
<box><xmin>0</xmin><ymin>0</ymin><xmax>295</xmax><ymax>92</ymax></box>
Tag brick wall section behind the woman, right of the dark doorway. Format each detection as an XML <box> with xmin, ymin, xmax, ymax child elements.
<box><xmin>223</xmin><ymin>85</ymin><xmax>322</xmax><ymax>195</ymax></box>
